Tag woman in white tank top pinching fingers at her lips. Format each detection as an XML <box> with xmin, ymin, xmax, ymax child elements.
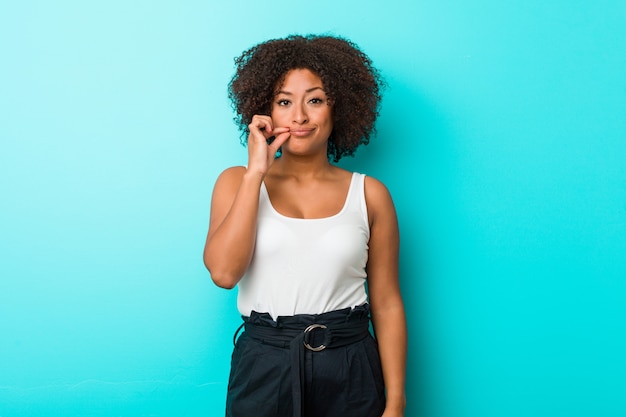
<box><xmin>204</xmin><ymin>36</ymin><xmax>406</xmax><ymax>417</ymax></box>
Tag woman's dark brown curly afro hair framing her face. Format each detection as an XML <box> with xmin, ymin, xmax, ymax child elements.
<box><xmin>228</xmin><ymin>35</ymin><xmax>384</xmax><ymax>162</ymax></box>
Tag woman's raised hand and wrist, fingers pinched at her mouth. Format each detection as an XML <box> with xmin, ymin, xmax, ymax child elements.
<box><xmin>248</xmin><ymin>115</ymin><xmax>290</xmax><ymax>176</ymax></box>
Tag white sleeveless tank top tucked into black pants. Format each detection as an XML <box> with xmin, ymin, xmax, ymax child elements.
<box><xmin>237</xmin><ymin>173</ymin><xmax>370</xmax><ymax>319</ymax></box>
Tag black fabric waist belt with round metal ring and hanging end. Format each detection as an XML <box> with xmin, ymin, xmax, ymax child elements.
<box><xmin>235</xmin><ymin>305</ymin><xmax>369</xmax><ymax>417</ymax></box>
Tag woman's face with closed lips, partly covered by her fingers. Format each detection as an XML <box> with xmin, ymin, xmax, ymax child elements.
<box><xmin>271</xmin><ymin>69</ymin><xmax>333</xmax><ymax>154</ymax></box>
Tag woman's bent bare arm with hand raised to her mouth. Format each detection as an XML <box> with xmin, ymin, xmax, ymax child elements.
<box><xmin>204</xmin><ymin>115</ymin><xmax>289</xmax><ymax>288</ymax></box>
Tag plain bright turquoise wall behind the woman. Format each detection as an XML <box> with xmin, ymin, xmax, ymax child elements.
<box><xmin>0</xmin><ymin>0</ymin><xmax>626</xmax><ymax>417</ymax></box>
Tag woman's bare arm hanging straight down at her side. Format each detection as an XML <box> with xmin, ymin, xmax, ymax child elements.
<box><xmin>365</xmin><ymin>177</ymin><xmax>407</xmax><ymax>417</ymax></box>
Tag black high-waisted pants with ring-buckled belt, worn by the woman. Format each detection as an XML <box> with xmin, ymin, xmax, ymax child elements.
<box><xmin>226</xmin><ymin>305</ymin><xmax>385</xmax><ymax>417</ymax></box>
